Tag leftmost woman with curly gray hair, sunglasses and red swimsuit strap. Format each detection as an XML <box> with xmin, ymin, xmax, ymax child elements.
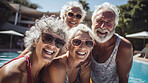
<box><xmin>0</xmin><ymin>16</ymin><xmax>66</xmax><ymax>83</ymax></box>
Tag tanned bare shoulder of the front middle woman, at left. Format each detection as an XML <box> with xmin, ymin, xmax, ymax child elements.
<box><xmin>43</xmin><ymin>53</ymin><xmax>66</xmax><ymax>83</ymax></box>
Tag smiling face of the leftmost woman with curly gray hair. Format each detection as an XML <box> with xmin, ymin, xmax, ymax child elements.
<box><xmin>35</xmin><ymin>31</ymin><xmax>63</xmax><ymax>62</ymax></box>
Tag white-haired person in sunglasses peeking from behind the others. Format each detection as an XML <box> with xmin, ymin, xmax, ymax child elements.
<box><xmin>60</xmin><ymin>1</ymin><xmax>86</xmax><ymax>29</ymax></box>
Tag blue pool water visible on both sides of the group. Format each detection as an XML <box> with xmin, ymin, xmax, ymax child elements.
<box><xmin>0</xmin><ymin>52</ymin><xmax>148</xmax><ymax>83</ymax></box>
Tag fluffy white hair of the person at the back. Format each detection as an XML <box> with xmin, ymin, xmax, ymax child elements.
<box><xmin>60</xmin><ymin>1</ymin><xmax>86</xmax><ymax>22</ymax></box>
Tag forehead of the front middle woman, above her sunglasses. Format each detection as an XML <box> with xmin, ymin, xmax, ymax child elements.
<box><xmin>74</xmin><ymin>31</ymin><xmax>91</xmax><ymax>40</ymax></box>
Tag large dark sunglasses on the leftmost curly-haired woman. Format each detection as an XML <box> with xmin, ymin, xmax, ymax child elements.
<box><xmin>42</xmin><ymin>33</ymin><xmax>66</xmax><ymax>48</ymax></box>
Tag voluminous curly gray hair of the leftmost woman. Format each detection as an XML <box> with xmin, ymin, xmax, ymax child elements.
<box><xmin>24</xmin><ymin>15</ymin><xmax>67</xmax><ymax>50</ymax></box>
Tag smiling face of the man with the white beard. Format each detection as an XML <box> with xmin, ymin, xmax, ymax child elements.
<box><xmin>92</xmin><ymin>9</ymin><xmax>115</xmax><ymax>43</ymax></box>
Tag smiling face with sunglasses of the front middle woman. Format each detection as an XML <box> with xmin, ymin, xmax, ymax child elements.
<box><xmin>70</xmin><ymin>31</ymin><xmax>94</xmax><ymax>61</ymax></box>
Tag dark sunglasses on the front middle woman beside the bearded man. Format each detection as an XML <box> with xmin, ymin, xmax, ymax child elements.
<box><xmin>72</xmin><ymin>39</ymin><xmax>94</xmax><ymax>48</ymax></box>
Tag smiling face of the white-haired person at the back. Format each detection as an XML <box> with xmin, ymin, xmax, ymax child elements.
<box><xmin>65</xmin><ymin>7</ymin><xmax>82</xmax><ymax>28</ymax></box>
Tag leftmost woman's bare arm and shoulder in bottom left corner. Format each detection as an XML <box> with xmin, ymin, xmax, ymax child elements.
<box><xmin>0</xmin><ymin>58</ymin><xmax>27</xmax><ymax>83</ymax></box>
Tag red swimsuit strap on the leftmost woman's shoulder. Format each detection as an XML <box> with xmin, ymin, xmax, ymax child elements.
<box><xmin>24</xmin><ymin>55</ymin><xmax>32</xmax><ymax>83</ymax></box>
